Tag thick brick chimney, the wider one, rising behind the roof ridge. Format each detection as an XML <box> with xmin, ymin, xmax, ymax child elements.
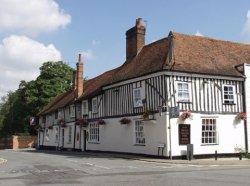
<box><xmin>126</xmin><ymin>18</ymin><xmax>146</xmax><ymax>60</ymax></box>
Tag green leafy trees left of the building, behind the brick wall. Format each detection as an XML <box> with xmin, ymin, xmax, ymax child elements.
<box><xmin>0</xmin><ymin>61</ymin><xmax>73</xmax><ymax>137</ymax></box>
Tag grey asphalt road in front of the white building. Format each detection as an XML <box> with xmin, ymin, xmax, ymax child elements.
<box><xmin>0</xmin><ymin>150</ymin><xmax>250</xmax><ymax>186</ymax></box>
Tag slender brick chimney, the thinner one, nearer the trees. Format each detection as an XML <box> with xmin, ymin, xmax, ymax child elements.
<box><xmin>74</xmin><ymin>54</ymin><xmax>83</xmax><ymax>98</ymax></box>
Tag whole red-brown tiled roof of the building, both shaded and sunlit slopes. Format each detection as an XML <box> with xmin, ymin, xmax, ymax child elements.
<box><xmin>40</xmin><ymin>32</ymin><xmax>250</xmax><ymax>114</ymax></box>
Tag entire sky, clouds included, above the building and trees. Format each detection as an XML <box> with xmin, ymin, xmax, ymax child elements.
<box><xmin>0</xmin><ymin>0</ymin><xmax>250</xmax><ymax>96</ymax></box>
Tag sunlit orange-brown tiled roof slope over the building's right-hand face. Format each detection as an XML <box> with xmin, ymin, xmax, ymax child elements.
<box><xmin>172</xmin><ymin>33</ymin><xmax>250</xmax><ymax>77</ymax></box>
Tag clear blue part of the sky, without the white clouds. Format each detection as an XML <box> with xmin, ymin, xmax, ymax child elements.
<box><xmin>44</xmin><ymin>0</ymin><xmax>250</xmax><ymax>77</ymax></box>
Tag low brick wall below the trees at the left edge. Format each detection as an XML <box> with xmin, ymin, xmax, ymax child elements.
<box><xmin>0</xmin><ymin>136</ymin><xmax>37</xmax><ymax>149</ymax></box>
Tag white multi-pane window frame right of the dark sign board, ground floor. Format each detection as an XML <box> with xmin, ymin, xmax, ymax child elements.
<box><xmin>201</xmin><ymin>117</ymin><xmax>219</xmax><ymax>145</ymax></box>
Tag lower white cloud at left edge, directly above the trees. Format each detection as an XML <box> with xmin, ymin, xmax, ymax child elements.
<box><xmin>0</xmin><ymin>35</ymin><xmax>61</xmax><ymax>97</ymax></box>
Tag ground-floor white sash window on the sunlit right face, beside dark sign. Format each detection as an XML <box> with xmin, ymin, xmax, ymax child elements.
<box><xmin>201</xmin><ymin>118</ymin><xmax>218</xmax><ymax>144</ymax></box>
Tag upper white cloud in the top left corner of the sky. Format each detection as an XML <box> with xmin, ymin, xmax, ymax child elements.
<box><xmin>0</xmin><ymin>0</ymin><xmax>71</xmax><ymax>35</ymax></box>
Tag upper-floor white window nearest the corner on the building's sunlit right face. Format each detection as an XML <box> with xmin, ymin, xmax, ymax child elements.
<box><xmin>177</xmin><ymin>82</ymin><xmax>190</xmax><ymax>102</ymax></box>
